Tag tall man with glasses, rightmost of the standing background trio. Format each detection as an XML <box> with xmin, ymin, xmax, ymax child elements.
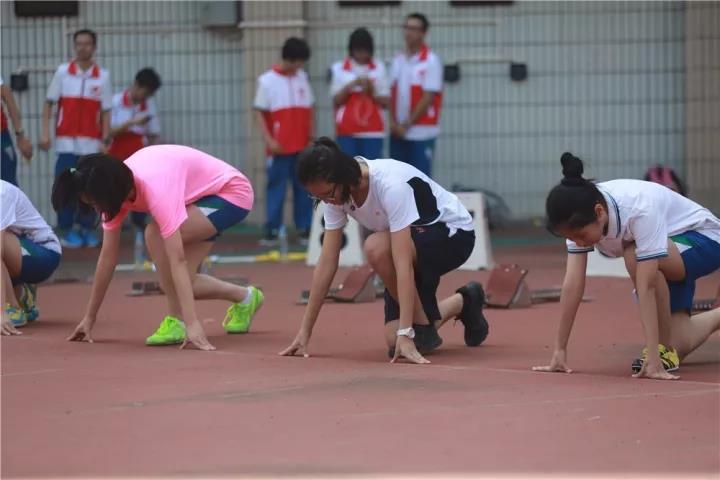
<box><xmin>390</xmin><ymin>13</ymin><xmax>443</xmax><ymax>176</ymax></box>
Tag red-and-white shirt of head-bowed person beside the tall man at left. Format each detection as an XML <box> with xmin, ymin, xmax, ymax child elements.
<box><xmin>109</xmin><ymin>90</ymin><xmax>160</xmax><ymax>160</ymax></box>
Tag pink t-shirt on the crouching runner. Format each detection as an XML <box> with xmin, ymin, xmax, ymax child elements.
<box><xmin>103</xmin><ymin>145</ymin><xmax>254</xmax><ymax>238</ymax></box>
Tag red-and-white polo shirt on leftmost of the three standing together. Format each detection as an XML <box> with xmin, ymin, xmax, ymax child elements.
<box><xmin>253</xmin><ymin>66</ymin><xmax>315</xmax><ymax>154</ymax></box>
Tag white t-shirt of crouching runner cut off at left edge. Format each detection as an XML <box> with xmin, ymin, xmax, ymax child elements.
<box><xmin>0</xmin><ymin>180</ymin><xmax>62</xmax><ymax>253</ymax></box>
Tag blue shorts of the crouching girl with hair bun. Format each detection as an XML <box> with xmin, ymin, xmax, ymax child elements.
<box><xmin>668</xmin><ymin>231</ymin><xmax>720</xmax><ymax>312</ymax></box>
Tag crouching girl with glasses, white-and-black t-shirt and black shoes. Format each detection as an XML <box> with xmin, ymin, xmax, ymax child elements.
<box><xmin>280</xmin><ymin>137</ymin><xmax>488</xmax><ymax>363</ymax></box>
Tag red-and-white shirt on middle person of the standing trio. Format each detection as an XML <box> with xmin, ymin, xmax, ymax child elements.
<box><xmin>330</xmin><ymin>58</ymin><xmax>390</xmax><ymax>138</ymax></box>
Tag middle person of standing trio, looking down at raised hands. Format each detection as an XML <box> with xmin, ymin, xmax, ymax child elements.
<box><xmin>330</xmin><ymin>28</ymin><xmax>390</xmax><ymax>159</ymax></box>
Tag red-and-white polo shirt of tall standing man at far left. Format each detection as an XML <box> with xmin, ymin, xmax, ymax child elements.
<box><xmin>47</xmin><ymin>61</ymin><xmax>112</xmax><ymax>155</ymax></box>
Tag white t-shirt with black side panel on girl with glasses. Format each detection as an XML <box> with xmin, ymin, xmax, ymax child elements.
<box><xmin>324</xmin><ymin>157</ymin><xmax>474</xmax><ymax>236</ymax></box>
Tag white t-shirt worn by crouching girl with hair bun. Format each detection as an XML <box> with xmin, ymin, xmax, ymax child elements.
<box><xmin>567</xmin><ymin>180</ymin><xmax>720</xmax><ymax>261</ymax></box>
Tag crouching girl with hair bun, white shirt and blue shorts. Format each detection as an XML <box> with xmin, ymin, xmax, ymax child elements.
<box><xmin>533</xmin><ymin>152</ymin><xmax>720</xmax><ymax>380</ymax></box>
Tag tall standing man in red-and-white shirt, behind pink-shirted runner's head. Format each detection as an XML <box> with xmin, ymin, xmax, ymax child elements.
<box><xmin>39</xmin><ymin>29</ymin><xmax>112</xmax><ymax>248</ymax></box>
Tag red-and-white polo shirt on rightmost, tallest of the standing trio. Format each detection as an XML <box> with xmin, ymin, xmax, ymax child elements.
<box><xmin>390</xmin><ymin>45</ymin><xmax>443</xmax><ymax>140</ymax></box>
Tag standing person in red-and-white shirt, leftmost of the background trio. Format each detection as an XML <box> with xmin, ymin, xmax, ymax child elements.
<box><xmin>254</xmin><ymin>37</ymin><xmax>315</xmax><ymax>245</ymax></box>
